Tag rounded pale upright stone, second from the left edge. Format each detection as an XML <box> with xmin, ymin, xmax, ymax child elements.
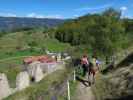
<box><xmin>16</xmin><ymin>71</ymin><xmax>30</xmax><ymax>90</ymax></box>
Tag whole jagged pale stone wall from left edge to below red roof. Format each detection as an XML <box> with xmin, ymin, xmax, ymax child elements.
<box><xmin>0</xmin><ymin>62</ymin><xmax>65</xmax><ymax>100</ymax></box>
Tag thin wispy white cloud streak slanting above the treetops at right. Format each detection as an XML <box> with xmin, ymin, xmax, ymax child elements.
<box><xmin>75</xmin><ymin>4</ymin><xmax>112</xmax><ymax>11</ymax></box>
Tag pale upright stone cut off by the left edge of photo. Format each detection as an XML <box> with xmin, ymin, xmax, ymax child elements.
<box><xmin>0</xmin><ymin>73</ymin><xmax>11</xmax><ymax>100</ymax></box>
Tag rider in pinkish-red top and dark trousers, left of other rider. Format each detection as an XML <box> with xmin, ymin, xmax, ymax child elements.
<box><xmin>81</xmin><ymin>55</ymin><xmax>89</xmax><ymax>76</ymax></box>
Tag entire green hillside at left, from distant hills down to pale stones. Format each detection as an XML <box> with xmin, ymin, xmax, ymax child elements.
<box><xmin>0</xmin><ymin>30</ymin><xmax>70</xmax><ymax>87</ymax></box>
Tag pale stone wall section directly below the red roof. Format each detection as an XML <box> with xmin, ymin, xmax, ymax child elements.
<box><xmin>27</xmin><ymin>61</ymin><xmax>65</xmax><ymax>82</ymax></box>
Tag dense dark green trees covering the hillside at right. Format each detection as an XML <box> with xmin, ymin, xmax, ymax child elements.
<box><xmin>55</xmin><ymin>8</ymin><xmax>133</xmax><ymax>55</ymax></box>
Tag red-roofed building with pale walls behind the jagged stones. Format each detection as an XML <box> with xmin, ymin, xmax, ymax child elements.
<box><xmin>23</xmin><ymin>55</ymin><xmax>65</xmax><ymax>77</ymax></box>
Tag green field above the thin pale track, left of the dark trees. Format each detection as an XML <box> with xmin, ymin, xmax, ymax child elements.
<box><xmin>0</xmin><ymin>31</ymin><xmax>71</xmax><ymax>59</ymax></box>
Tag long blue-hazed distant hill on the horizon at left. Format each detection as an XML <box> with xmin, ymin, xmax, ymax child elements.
<box><xmin>0</xmin><ymin>17</ymin><xmax>64</xmax><ymax>31</ymax></box>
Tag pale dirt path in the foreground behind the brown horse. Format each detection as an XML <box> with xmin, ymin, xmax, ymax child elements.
<box><xmin>76</xmin><ymin>82</ymin><xmax>95</xmax><ymax>100</ymax></box>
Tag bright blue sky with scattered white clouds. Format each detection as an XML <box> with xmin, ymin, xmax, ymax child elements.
<box><xmin>0</xmin><ymin>0</ymin><xmax>133</xmax><ymax>19</ymax></box>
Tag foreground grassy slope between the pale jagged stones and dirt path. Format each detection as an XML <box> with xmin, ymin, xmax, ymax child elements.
<box><xmin>4</xmin><ymin>68</ymin><xmax>77</xmax><ymax>100</ymax></box>
